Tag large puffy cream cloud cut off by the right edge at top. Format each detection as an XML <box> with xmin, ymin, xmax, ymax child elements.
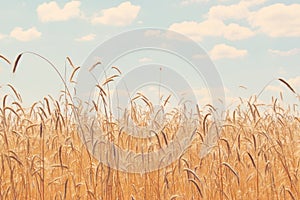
<box><xmin>249</xmin><ymin>4</ymin><xmax>300</xmax><ymax>37</ymax></box>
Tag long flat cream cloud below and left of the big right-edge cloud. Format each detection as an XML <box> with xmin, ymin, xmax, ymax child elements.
<box><xmin>169</xmin><ymin>19</ymin><xmax>255</xmax><ymax>41</ymax></box>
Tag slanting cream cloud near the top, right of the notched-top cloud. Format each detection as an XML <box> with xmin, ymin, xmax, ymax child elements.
<box><xmin>92</xmin><ymin>1</ymin><xmax>140</xmax><ymax>26</ymax></box>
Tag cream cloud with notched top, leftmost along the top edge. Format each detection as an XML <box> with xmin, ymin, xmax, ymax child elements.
<box><xmin>37</xmin><ymin>1</ymin><xmax>81</xmax><ymax>22</ymax></box>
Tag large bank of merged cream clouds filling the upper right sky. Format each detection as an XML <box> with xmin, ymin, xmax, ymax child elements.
<box><xmin>169</xmin><ymin>0</ymin><xmax>300</xmax><ymax>41</ymax></box>
